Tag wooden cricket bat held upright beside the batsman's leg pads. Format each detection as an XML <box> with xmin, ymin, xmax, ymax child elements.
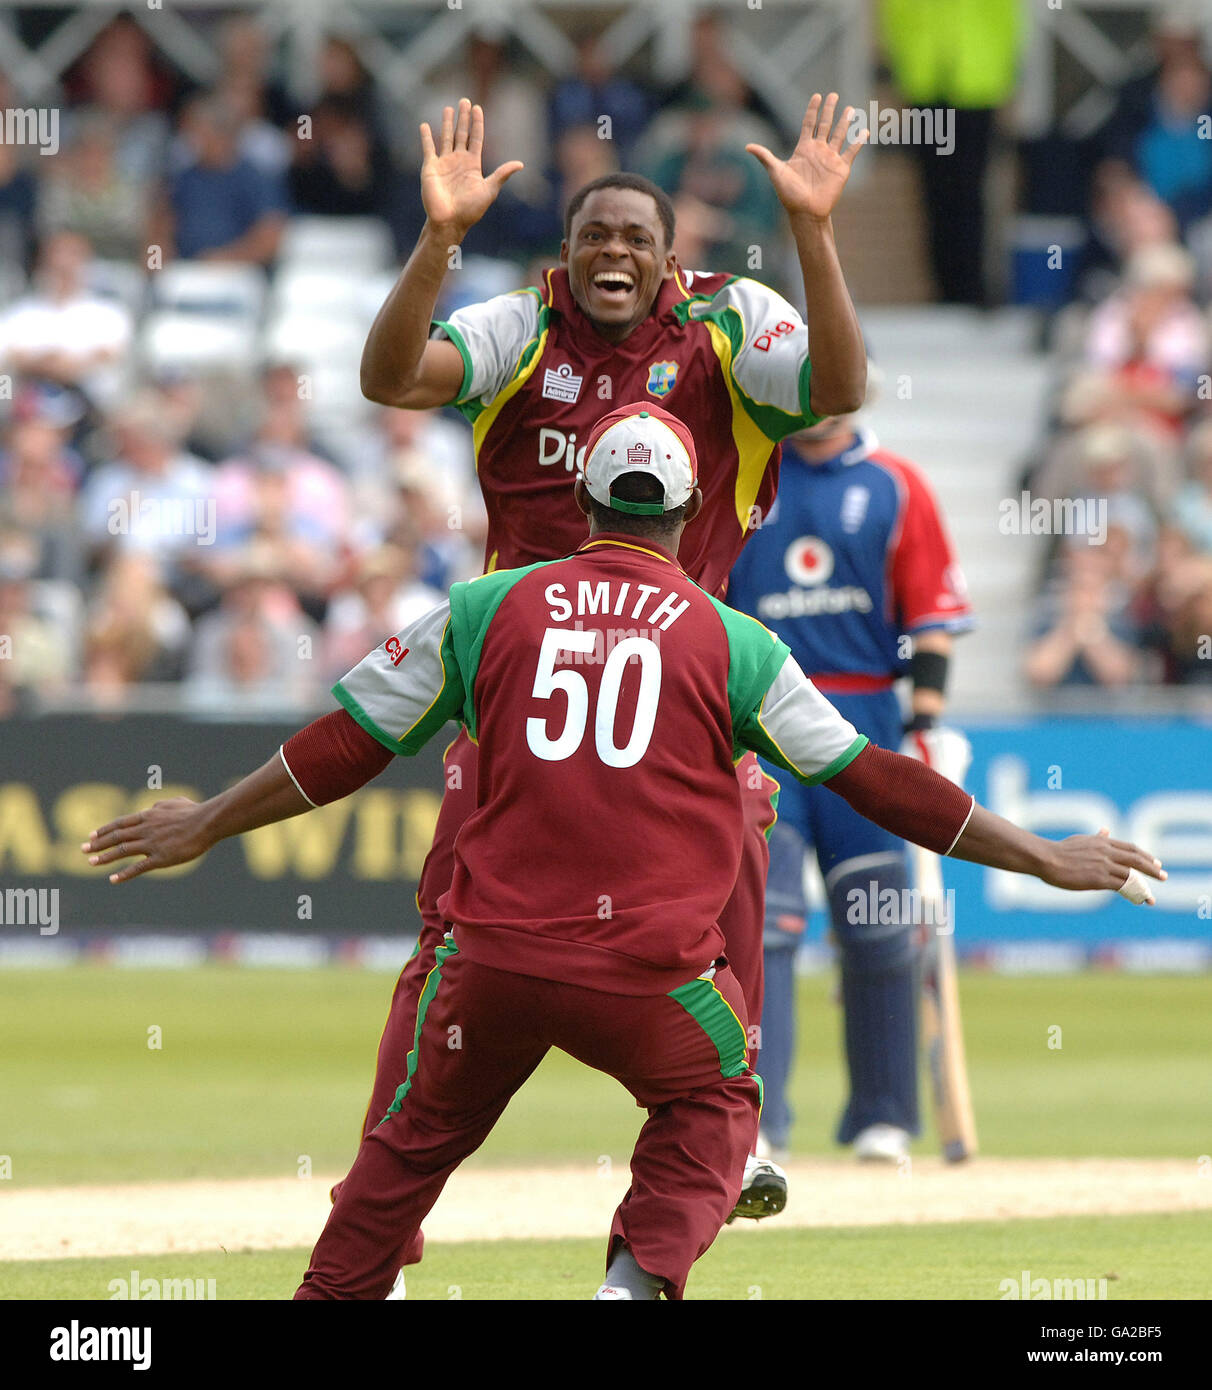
<box><xmin>910</xmin><ymin>845</ymin><xmax>977</xmax><ymax>1163</ymax></box>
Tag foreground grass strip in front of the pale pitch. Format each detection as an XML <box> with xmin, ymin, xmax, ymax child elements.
<box><xmin>0</xmin><ymin>1212</ymin><xmax>1212</xmax><ymax>1300</ymax></box>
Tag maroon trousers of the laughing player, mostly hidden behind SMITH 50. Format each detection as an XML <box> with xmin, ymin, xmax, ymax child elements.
<box><xmin>332</xmin><ymin>730</ymin><xmax>778</xmax><ymax>1265</ymax></box>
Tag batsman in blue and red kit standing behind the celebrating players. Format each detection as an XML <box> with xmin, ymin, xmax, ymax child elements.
<box><xmin>728</xmin><ymin>405</ymin><xmax>972</xmax><ymax>1161</ymax></box>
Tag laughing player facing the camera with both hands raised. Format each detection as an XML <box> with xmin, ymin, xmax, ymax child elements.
<box><xmin>350</xmin><ymin>93</ymin><xmax>866</xmax><ymax>1264</ymax></box>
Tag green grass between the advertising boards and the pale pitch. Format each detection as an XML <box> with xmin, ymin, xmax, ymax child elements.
<box><xmin>0</xmin><ymin>965</ymin><xmax>1212</xmax><ymax>1184</ymax></box>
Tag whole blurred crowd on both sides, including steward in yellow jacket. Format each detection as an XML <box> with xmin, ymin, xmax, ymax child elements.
<box><xmin>7</xmin><ymin>0</ymin><xmax>1212</xmax><ymax>716</ymax></box>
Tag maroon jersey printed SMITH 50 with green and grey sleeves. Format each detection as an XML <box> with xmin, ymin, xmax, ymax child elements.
<box><xmin>335</xmin><ymin>532</ymin><xmax>866</xmax><ymax>994</ymax></box>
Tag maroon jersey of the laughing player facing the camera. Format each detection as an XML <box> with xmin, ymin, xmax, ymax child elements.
<box><xmin>432</xmin><ymin>268</ymin><xmax>817</xmax><ymax>594</ymax></box>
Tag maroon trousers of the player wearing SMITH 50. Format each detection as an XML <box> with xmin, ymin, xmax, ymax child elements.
<box><xmin>295</xmin><ymin>929</ymin><xmax>760</xmax><ymax>1300</ymax></box>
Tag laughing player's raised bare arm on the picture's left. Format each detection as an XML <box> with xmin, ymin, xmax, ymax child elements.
<box><xmin>361</xmin><ymin>97</ymin><xmax>523</xmax><ymax>410</ymax></box>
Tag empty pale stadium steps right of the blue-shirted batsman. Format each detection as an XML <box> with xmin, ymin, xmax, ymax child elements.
<box><xmin>859</xmin><ymin>306</ymin><xmax>1052</xmax><ymax>716</ymax></box>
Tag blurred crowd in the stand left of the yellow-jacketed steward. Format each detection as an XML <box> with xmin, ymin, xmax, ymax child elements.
<box><xmin>0</xmin><ymin>14</ymin><xmax>794</xmax><ymax>716</ymax></box>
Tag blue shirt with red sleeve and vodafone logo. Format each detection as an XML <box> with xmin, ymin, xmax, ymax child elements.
<box><xmin>728</xmin><ymin>430</ymin><xmax>973</xmax><ymax>680</ymax></box>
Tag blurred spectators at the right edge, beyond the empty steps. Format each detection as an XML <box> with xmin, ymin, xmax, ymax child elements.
<box><xmin>1024</xmin><ymin>11</ymin><xmax>1212</xmax><ymax>687</ymax></box>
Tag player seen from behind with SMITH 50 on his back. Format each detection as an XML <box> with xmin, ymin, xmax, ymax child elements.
<box><xmin>85</xmin><ymin>402</ymin><xmax>1163</xmax><ymax>1301</ymax></box>
